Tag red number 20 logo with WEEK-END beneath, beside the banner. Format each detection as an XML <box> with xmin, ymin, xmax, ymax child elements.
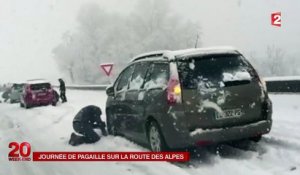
<box><xmin>8</xmin><ymin>142</ymin><xmax>31</xmax><ymax>161</ymax></box>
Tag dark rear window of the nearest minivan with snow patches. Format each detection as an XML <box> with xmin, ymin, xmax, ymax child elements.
<box><xmin>177</xmin><ymin>54</ymin><xmax>254</xmax><ymax>89</ymax></box>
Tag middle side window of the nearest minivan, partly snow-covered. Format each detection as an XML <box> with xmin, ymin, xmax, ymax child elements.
<box><xmin>129</xmin><ymin>62</ymin><xmax>150</xmax><ymax>90</ymax></box>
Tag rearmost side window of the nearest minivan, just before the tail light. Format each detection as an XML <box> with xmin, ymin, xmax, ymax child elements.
<box><xmin>144</xmin><ymin>63</ymin><xmax>170</xmax><ymax>89</ymax></box>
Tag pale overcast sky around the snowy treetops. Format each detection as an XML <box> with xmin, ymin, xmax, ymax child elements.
<box><xmin>0</xmin><ymin>0</ymin><xmax>300</xmax><ymax>83</ymax></box>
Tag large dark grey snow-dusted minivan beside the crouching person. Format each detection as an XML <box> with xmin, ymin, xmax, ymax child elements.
<box><xmin>106</xmin><ymin>47</ymin><xmax>272</xmax><ymax>151</ymax></box>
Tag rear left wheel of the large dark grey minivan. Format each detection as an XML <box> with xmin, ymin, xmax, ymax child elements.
<box><xmin>148</xmin><ymin>121</ymin><xmax>167</xmax><ymax>152</ymax></box>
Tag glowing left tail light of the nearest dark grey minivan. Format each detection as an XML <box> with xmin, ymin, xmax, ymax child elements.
<box><xmin>167</xmin><ymin>77</ymin><xmax>181</xmax><ymax>105</ymax></box>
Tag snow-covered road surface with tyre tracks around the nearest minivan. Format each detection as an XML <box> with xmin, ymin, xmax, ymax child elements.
<box><xmin>0</xmin><ymin>91</ymin><xmax>300</xmax><ymax>175</ymax></box>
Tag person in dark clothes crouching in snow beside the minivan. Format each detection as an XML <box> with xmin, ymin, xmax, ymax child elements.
<box><xmin>69</xmin><ymin>105</ymin><xmax>107</xmax><ymax>146</ymax></box>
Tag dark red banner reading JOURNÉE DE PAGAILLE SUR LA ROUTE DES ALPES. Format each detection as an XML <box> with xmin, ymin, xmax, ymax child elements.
<box><xmin>33</xmin><ymin>152</ymin><xmax>190</xmax><ymax>162</ymax></box>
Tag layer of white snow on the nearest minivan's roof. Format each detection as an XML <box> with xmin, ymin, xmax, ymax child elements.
<box><xmin>131</xmin><ymin>46</ymin><xmax>239</xmax><ymax>62</ymax></box>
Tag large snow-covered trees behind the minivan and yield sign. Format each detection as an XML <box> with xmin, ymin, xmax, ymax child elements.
<box><xmin>53</xmin><ymin>0</ymin><xmax>200</xmax><ymax>83</ymax></box>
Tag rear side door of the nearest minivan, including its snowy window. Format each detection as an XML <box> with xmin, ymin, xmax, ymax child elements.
<box><xmin>125</xmin><ymin>61</ymin><xmax>150</xmax><ymax>139</ymax></box>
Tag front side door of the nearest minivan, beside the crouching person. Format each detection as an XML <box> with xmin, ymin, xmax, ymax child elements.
<box><xmin>111</xmin><ymin>65</ymin><xmax>134</xmax><ymax>135</ymax></box>
